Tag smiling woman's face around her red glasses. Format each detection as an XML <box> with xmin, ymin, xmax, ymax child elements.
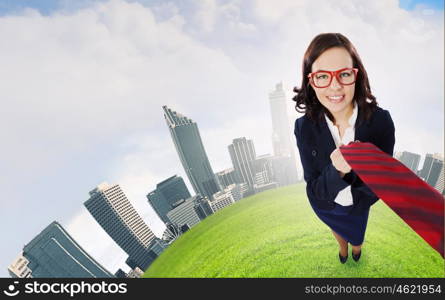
<box><xmin>311</xmin><ymin>47</ymin><xmax>355</xmax><ymax>117</ymax></box>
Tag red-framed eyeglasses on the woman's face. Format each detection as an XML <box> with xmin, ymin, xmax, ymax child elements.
<box><xmin>307</xmin><ymin>68</ymin><xmax>358</xmax><ymax>88</ymax></box>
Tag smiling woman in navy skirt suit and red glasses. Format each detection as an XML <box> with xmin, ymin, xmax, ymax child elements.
<box><xmin>293</xmin><ymin>33</ymin><xmax>395</xmax><ymax>263</ymax></box>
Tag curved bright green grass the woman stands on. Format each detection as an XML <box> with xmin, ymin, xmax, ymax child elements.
<box><xmin>144</xmin><ymin>184</ymin><xmax>444</xmax><ymax>278</ymax></box>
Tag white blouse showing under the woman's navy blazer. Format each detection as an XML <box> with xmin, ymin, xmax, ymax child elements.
<box><xmin>325</xmin><ymin>102</ymin><xmax>358</xmax><ymax>206</ymax></box>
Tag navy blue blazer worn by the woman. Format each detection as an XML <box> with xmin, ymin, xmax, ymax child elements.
<box><xmin>294</xmin><ymin>107</ymin><xmax>395</xmax><ymax>215</ymax></box>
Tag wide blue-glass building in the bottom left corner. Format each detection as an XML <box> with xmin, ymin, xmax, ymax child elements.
<box><xmin>8</xmin><ymin>221</ymin><xmax>114</xmax><ymax>278</ymax></box>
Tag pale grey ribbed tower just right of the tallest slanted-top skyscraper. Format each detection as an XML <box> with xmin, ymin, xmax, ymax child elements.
<box><xmin>228</xmin><ymin>137</ymin><xmax>256</xmax><ymax>190</ymax></box>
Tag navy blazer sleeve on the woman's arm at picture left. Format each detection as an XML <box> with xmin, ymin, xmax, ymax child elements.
<box><xmin>294</xmin><ymin>119</ymin><xmax>349</xmax><ymax>202</ymax></box>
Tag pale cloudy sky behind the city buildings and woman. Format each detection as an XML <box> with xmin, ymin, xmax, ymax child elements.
<box><xmin>0</xmin><ymin>0</ymin><xmax>444</xmax><ymax>277</ymax></box>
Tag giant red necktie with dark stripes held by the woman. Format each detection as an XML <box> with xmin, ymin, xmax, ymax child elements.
<box><xmin>340</xmin><ymin>142</ymin><xmax>444</xmax><ymax>257</ymax></box>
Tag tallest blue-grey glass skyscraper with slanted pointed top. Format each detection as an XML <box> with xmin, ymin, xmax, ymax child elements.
<box><xmin>162</xmin><ymin>105</ymin><xmax>221</xmax><ymax>199</ymax></box>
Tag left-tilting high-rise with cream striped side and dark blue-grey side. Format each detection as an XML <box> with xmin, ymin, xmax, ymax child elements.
<box><xmin>84</xmin><ymin>182</ymin><xmax>155</xmax><ymax>270</ymax></box>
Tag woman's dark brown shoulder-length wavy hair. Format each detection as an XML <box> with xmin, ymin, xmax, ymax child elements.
<box><xmin>292</xmin><ymin>33</ymin><xmax>378</xmax><ymax>123</ymax></box>
